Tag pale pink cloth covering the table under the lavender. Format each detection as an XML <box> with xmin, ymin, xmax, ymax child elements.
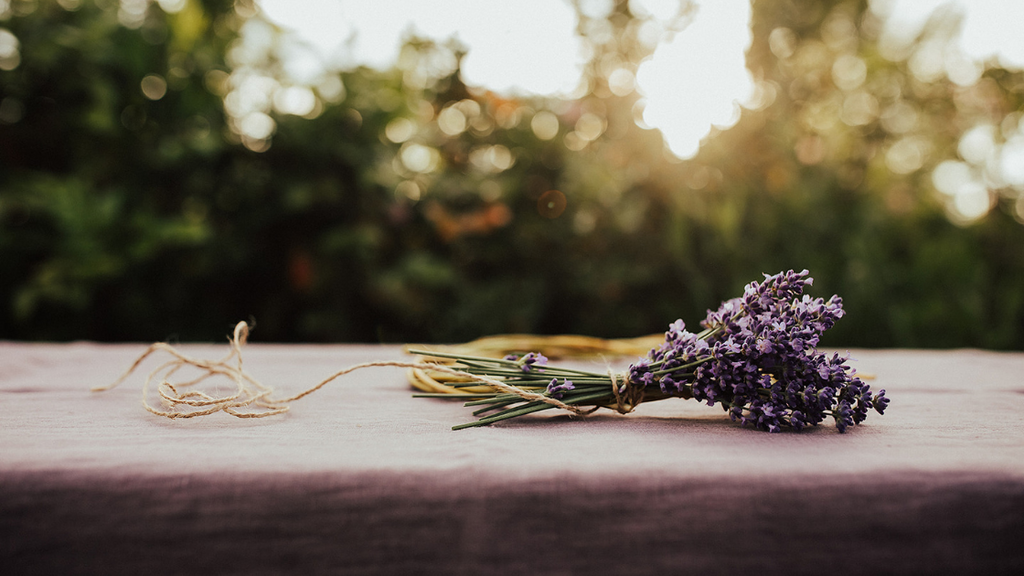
<box><xmin>0</xmin><ymin>343</ymin><xmax>1024</xmax><ymax>574</ymax></box>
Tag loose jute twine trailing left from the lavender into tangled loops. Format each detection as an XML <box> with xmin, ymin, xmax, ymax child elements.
<box><xmin>92</xmin><ymin>322</ymin><xmax>593</xmax><ymax>418</ymax></box>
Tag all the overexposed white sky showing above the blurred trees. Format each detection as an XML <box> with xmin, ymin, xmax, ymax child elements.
<box><xmin>253</xmin><ymin>0</ymin><xmax>1024</xmax><ymax>158</ymax></box>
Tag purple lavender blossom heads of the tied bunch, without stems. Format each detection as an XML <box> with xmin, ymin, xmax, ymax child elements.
<box><xmin>629</xmin><ymin>270</ymin><xmax>889</xmax><ymax>431</ymax></box>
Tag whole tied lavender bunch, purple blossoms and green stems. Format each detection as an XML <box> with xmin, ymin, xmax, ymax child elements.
<box><xmin>410</xmin><ymin>270</ymin><xmax>889</xmax><ymax>433</ymax></box>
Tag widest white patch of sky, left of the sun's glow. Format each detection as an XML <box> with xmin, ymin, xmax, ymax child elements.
<box><xmin>260</xmin><ymin>0</ymin><xmax>585</xmax><ymax>95</ymax></box>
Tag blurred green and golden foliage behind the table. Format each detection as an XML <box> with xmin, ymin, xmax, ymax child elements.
<box><xmin>0</xmin><ymin>0</ymin><xmax>1024</xmax><ymax>348</ymax></box>
